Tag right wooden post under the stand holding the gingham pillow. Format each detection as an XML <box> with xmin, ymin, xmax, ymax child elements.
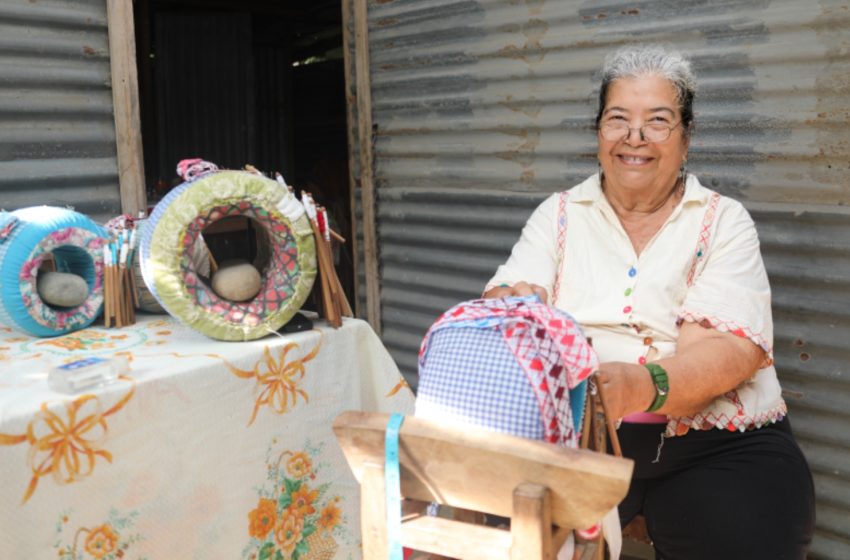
<box><xmin>511</xmin><ymin>483</ymin><xmax>554</xmax><ymax>560</ymax></box>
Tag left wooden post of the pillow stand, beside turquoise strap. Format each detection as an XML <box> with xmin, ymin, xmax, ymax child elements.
<box><xmin>360</xmin><ymin>463</ymin><xmax>389</xmax><ymax>558</ymax></box>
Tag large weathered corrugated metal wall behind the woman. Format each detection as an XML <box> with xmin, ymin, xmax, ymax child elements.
<box><xmin>348</xmin><ymin>0</ymin><xmax>850</xmax><ymax>560</ymax></box>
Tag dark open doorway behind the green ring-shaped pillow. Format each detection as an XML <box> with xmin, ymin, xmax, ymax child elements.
<box><xmin>134</xmin><ymin>0</ymin><xmax>354</xmax><ymax>302</ymax></box>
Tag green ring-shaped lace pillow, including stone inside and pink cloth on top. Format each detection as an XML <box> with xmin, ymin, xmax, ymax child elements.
<box><xmin>140</xmin><ymin>159</ymin><xmax>317</xmax><ymax>340</ymax></box>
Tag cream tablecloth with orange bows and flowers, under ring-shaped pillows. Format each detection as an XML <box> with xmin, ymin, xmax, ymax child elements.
<box><xmin>0</xmin><ymin>315</ymin><xmax>413</xmax><ymax>560</ymax></box>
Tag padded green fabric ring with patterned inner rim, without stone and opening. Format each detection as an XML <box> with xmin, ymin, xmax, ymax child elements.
<box><xmin>140</xmin><ymin>171</ymin><xmax>316</xmax><ymax>341</ymax></box>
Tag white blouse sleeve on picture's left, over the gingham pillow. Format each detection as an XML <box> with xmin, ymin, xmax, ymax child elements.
<box><xmin>483</xmin><ymin>193</ymin><xmax>560</xmax><ymax>301</ymax></box>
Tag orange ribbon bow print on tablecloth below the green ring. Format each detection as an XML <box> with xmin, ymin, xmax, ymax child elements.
<box><xmin>224</xmin><ymin>338</ymin><xmax>322</xmax><ymax>426</ymax></box>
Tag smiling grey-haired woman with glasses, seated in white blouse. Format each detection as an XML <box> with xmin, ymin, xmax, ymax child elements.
<box><xmin>485</xmin><ymin>46</ymin><xmax>814</xmax><ymax>560</ymax></box>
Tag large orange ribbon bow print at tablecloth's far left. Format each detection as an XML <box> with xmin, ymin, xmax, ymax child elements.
<box><xmin>0</xmin><ymin>375</ymin><xmax>135</xmax><ymax>502</ymax></box>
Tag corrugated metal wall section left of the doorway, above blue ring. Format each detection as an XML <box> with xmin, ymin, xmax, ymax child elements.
<box><xmin>0</xmin><ymin>0</ymin><xmax>121</xmax><ymax>219</ymax></box>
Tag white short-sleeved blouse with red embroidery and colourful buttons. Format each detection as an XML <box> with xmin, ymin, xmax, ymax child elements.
<box><xmin>485</xmin><ymin>175</ymin><xmax>786</xmax><ymax>436</ymax></box>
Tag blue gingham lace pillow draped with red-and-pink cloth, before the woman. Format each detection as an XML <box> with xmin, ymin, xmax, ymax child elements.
<box><xmin>416</xmin><ymin>297</ymin><xmax>598</xmax><ymax>447</ymax></box>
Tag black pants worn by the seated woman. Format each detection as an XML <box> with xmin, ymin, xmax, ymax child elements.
<box><xmin>618</xmin><ymin>418</ymin><xmax>815</xmax><ymax>560</ymax></box>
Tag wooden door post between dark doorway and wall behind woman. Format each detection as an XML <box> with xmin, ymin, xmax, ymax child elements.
<box><xmin>353</xmin><ymin>0</ymin><xmax>381</xmax><ymax>335</ymax></box>
